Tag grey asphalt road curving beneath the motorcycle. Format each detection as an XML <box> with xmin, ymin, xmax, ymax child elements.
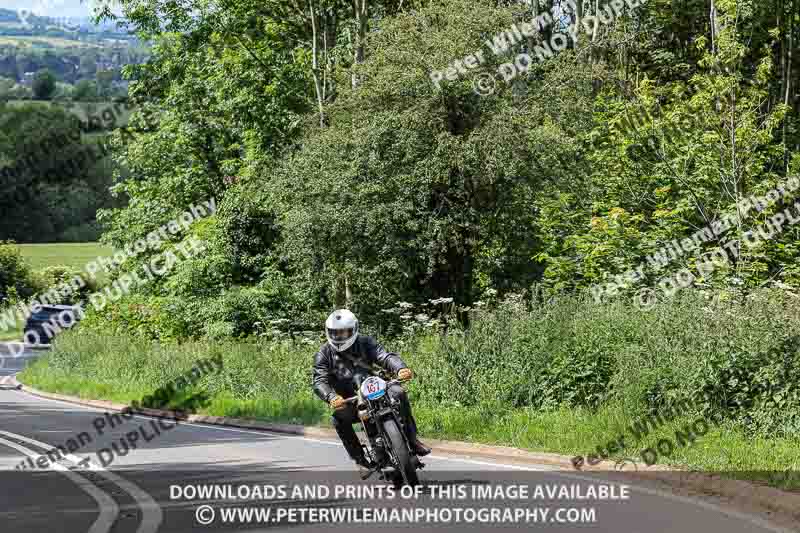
<box><xmin>0</xmin><ymin>344</ymin><xmax>792</xmax><ymax>533</ymax></box>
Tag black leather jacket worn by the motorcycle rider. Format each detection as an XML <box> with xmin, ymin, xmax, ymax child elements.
<box><xmin>312</xmin><ymin>335</ymin><xmax>406</xmax><ymax>402</ymax></box>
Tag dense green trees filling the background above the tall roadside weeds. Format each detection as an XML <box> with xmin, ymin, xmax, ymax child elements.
<box><xmin>64</xmin><ymin>0</ymin><xmax>800</xmax><ymax>344</ymax></box>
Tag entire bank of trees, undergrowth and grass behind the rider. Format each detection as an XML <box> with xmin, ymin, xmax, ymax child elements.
<box><xmin>0</xmin><ymin>0</ymin><xmax>800</xmax><ymax>494</ymax></box>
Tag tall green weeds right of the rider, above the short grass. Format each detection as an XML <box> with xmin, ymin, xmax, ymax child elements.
<box><xmin>410</xmin><ymin>291</ymin><xmax>800</xmax><ymax>436</ymax></box>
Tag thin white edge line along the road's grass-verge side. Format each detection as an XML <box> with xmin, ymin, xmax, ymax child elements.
<box><xmin>7</xmin><ymin>382</ymin><xmax>792</xmax><ymax>533</ymax></box>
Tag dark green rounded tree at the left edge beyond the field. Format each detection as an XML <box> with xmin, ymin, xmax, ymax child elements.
<box><xmin>0</xmin><ymin>104</ymin><xmax>120</xmax><ymax>242</ymax></box>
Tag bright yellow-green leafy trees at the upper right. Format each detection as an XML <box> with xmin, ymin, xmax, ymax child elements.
<box><xmin>539</xmin><ymin>2</ymin><xmax>800</xmax><ymax>298</ymax></box>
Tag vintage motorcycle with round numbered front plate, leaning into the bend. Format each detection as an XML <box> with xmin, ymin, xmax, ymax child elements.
<box><xmin>345</xmin><ymin>376</ymin><xmax>425</xmax><ymax>487</ymax></box>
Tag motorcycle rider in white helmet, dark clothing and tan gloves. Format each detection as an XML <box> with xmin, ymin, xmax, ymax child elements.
<box><xmin>312</xmin><ymin>309</ymin><xmax>431</xmax><ymax>468</ymax></box>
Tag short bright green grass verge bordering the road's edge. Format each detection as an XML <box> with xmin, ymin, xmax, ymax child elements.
<box><xmin>21</xmin><ymin>331</ymin><xmax>800</xmax><ymax>491</ymax></box>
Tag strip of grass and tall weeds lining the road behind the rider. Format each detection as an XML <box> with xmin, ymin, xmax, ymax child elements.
<box><xmin>21</xmin><ymin>291</ymin><xmax>800</xmax><ymax>490</ymax></box>
